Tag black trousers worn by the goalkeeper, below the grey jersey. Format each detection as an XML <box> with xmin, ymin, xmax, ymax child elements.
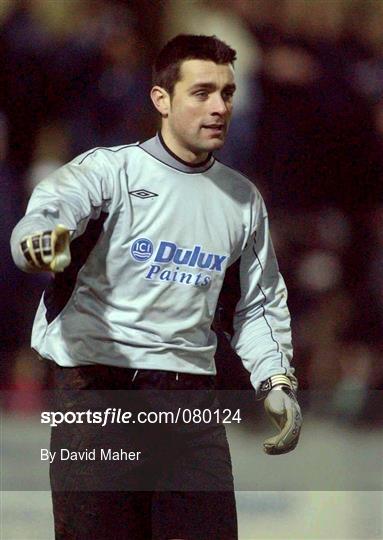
<box><xmin>49</xmin><ymin>363</ymin><xmax>237</xmax><ymax>540</ymax></box>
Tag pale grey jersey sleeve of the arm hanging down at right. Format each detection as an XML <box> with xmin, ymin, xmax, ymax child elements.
<box><xmin>232</xmin><ymin>194</ymin><xmax>294</xmax><ymax>392</ymax></box>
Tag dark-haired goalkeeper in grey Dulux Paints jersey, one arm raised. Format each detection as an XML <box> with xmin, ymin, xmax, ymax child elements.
<box><xmin>11</xmin><ymin>35</ymin><xmax>301</xmax><ymax>540</ymax></box>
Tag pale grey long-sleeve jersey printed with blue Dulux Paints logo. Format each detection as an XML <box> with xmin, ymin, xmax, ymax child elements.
<box><xmin>11</xmin><ymin>135</ymin><xmax>293</xmax><ymax>390</ymax></box>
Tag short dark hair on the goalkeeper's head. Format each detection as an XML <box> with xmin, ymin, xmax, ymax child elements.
<box><xmin>153</xmin><ymin>34</ymin><xmax>237</xmax><ymax>95</ymax></box>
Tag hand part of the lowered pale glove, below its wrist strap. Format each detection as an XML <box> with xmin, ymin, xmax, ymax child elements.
<box><xmin>263</xmin><ymin>386</ymin><xmax>302</xmax><ymax>455</ymax></box>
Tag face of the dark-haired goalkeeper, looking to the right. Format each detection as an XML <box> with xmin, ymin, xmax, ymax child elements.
<box><xmin>163</xmin><ymin>60</ymin><xmax>235</xmax><ymax>161</ymax></box>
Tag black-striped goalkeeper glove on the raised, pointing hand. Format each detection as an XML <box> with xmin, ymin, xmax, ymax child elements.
<box><xmin>20</xmin><ymin>225</ymin><xmax>71</xmax><ymax>272</ymax></box>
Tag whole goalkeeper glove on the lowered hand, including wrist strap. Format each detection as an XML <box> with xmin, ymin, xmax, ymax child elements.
<box><xmin>261</xmin><ymin>375</ymin><xmax>302</xmax><ymax>455</ymax></box>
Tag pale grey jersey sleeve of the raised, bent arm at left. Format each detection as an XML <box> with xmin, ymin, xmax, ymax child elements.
<box><xmin>11</xmin><ymin>149</ymin><xmax>112</xmax><ymax>272</ymax></box>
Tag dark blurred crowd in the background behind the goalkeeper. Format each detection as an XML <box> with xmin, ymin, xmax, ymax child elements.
<box><xmin>0</xmin><ymin>0</ymin><xmax>383</xmax><ymax>422</ymax></box>
